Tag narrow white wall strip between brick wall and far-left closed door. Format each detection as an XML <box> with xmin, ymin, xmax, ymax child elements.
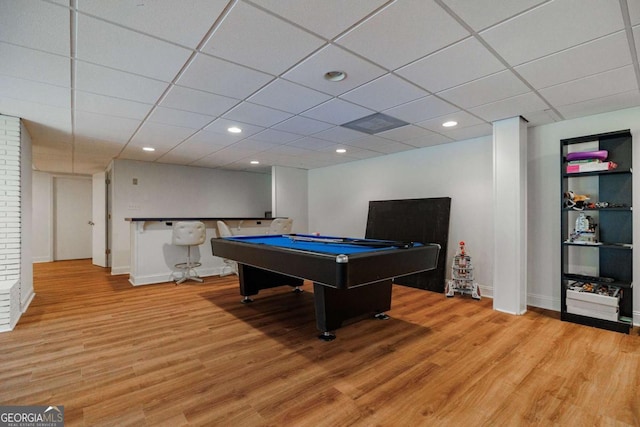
<box><xmin>31</xmin><ymin>171</ymin><xmax>53</xmax><ymax>262</ymax></box>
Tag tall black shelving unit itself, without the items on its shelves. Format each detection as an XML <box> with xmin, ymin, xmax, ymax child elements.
<box><xmin>560</xmin><ymin>130</ymin><xmax>633</xmax><ymax>333</ymax></box>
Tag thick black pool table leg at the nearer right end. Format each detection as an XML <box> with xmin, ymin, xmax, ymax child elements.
<box><xmin>313</xmin><ymin>280</ymin><xmax>392</xmax><ymax>341</ymax></box>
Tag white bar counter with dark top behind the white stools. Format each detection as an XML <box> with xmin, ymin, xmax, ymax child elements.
<box><xmin>125</xmin><ymin>218</ymin><xmax>273</xmax><ymax>286</ymax></box>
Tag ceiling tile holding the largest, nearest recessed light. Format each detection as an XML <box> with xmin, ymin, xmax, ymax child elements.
<box><xmin>283</xmin><ymin>45</ymin><xmax>385</xmax><ymax>96</ymax></box>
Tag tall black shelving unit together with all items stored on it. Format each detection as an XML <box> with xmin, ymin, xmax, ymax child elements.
<box><xmin>560</xmin><ymin>130</ymin><xmax>633</xmax><ymax>333</ymax></box>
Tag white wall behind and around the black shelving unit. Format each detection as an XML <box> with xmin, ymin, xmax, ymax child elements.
<box><xmin>528</xmin><ymin>108</ymin><xmax>640</xmax><ymax>323</ymax></box>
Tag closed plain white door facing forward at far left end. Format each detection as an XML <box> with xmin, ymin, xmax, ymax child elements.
<box><xmin>53</xmin><ymin>177</ymin><xmax>92</xmax><ymax>261</ymax></box>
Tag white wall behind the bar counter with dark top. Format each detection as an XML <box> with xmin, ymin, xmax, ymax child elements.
<box><xmin>111</xmin><ymin>160</ymin><xmax>271</xmax><ymax>274</ymax></box>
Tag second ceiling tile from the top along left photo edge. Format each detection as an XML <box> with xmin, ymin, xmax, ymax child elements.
<box><xmin>0</xmin><ymin>42</ymin><xmax>71</xmax><ymax>87</ymax></box>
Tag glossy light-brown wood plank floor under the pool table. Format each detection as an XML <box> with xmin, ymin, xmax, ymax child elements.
<box><xmin>0</xmin><ymin>260</ymin><xmax>640</xmax><ymax>427</ymax></box>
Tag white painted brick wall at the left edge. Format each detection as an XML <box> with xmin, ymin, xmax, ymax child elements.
<box><xmin>0</xmin><ymin>115</ymin><xmax>21</xmax><ymax>331</ymax></box>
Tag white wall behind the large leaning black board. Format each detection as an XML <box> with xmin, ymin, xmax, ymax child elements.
<box><xmin>309</xmin><ymin>136</ymin><xmax>493</xmax><ymax>293</ymax></box>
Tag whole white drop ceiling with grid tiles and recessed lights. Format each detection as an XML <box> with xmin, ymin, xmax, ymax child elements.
<box><xmin>0</xmin><ymin>0</ymin><xmax>640</xmax><ymax>174</ymax></box>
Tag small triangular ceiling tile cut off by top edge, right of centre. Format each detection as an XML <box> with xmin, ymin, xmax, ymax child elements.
<box><xmin>442</xmin><ymin>0</ymin><xmax>547</xmax><ymax>31</ymax></box>
